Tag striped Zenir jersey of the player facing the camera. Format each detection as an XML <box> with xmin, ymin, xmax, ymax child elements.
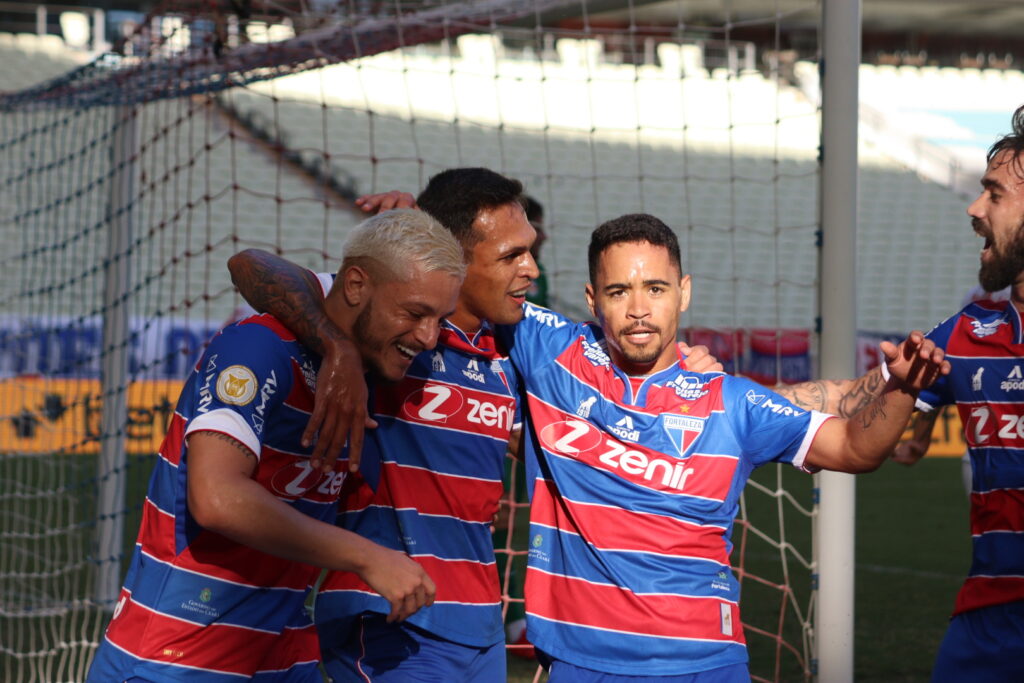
<box><xmin>502</xmin><ymin>305</ymin><xmax>827</xmax><ymax>676</ymax></box>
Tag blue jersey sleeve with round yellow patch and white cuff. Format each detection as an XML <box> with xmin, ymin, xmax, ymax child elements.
<box><xmin>185</xmin><ymin>324</ymin><xmax>293</xmax><ymax>458</ymax></box>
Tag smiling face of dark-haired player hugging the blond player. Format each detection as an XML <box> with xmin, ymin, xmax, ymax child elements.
<box><xmin>450</xmin><ymin>202</ymin><xmax>538</xmax><ymax>332</ymax></box>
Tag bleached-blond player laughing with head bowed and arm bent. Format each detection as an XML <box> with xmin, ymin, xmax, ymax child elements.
<box><xmin>89</xmin><ymin>210</ymin><xmax>465</xmax><ymax>683</ymax></box>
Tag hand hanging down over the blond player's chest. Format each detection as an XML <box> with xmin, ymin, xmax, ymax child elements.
<box><xmin>302</xmin><ymin>340</ymin><xmax>377</xmax><ymax>472</ymax></box>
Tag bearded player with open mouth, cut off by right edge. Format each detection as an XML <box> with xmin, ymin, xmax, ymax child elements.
<box><xmin>919</xmin><ymin>102</ymin><xmax>1024</xmax><ymax>683</ymax></box>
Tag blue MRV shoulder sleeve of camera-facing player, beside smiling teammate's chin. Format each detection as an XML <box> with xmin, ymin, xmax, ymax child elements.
<box><xmin>496</xmin><ymin>303</ymin><xmax>583</xmax><ymax>384</ymax></box>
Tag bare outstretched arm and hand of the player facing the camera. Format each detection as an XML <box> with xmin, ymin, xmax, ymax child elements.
<box><xmin>806</xmin><ymin>332</ymin><xmax>949</xmax><ymax>473</ymax></box>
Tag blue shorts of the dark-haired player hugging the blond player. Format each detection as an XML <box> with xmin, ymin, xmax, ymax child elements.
<box><xmin>321</xmin><ymin>613</ymin><xmax>506</xmax><ymax>683</ymax></box>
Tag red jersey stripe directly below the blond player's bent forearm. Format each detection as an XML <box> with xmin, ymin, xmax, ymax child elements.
<box><xmin>139</xmin><ymin>493</ymin><xmax>318</xmax><ymax>591</ymax></box>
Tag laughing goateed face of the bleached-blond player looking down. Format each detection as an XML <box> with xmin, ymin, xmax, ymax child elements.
<box><xmin>352</xmin><ymin>266</ymin><xmax>461</xmax><ymax>382</ymax></box>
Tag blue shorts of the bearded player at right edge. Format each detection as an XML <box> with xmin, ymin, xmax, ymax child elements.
<box><xmin>932</xmin><ymin>600</ymin><xmax>1024</xmax><ymax>683</ymax></box>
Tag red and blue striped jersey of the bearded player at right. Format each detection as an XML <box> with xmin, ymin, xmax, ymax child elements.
<box><xmin>919</xmin><ymin>301</ymin><xmax>1024</xmax><ymax>614</ymax></box>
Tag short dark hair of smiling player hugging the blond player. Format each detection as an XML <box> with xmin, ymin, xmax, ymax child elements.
<box><xmin>416</xmin><ymin>168</ymin><xmax>522</xmax><ymax>250</ymax></box>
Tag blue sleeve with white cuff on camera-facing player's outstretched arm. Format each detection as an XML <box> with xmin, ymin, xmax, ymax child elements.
<box><xmin>724</xmin><ymin>377</ymin><xmax>833</xmax><ymax>467</ymax></box>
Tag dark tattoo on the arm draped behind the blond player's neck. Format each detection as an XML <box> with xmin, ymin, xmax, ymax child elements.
<box><xmin>228</xmin><ymin>249</ymin><xmax>342</xmax><ymax>355</ymax></box>
